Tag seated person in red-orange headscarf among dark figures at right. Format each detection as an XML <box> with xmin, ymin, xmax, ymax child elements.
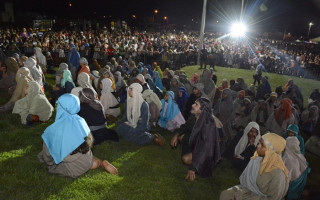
<box><xmin>266</xmin><ymin>98</ymin><xmax>294</xmax><ymax>136</ymax></box>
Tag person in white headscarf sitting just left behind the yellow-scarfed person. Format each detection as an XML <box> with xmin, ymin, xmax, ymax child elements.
<box><xmin>232</xmin><ymin>122</ymin><xmax>261</xmax><ymax>171</ymax></box>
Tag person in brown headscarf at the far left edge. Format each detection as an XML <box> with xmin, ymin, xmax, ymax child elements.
<box><xmin>0</xmin><ymin>57</ymin><xmax>19</xmax><ymax>89</ymax></box>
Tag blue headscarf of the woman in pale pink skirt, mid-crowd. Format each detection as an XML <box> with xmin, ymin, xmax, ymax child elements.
<box><xmin>159</xmin><ymin>91</ymin><xmax>180</xmax><ymax>128</ymax></box>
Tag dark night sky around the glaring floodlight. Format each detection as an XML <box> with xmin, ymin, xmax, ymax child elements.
<box><xmin>3</xmin><ymin>0</ymin><xmax>320</xmax><ymax>35</ymax></box>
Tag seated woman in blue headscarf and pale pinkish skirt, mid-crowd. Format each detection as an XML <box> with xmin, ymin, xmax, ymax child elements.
<box><xmin>158</xmin><ymin>91</ymin><xmax>186</xmax><ymax>132</ymax></box>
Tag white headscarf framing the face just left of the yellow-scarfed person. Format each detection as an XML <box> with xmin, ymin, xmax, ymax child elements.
<box><xmin>234</xmin><ymin>122</ymin><xmax>261</xmax><ymax>159</ymax></box>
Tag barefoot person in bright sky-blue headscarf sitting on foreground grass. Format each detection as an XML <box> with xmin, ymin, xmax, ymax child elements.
<box><xmin>38</xmin><ymin>94</ymin><xmax>118</xmax><ymax>178</ymax></box>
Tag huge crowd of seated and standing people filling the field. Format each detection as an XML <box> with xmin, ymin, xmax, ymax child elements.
<box><xmin>0</xmin><ymin>29</ymin><xmax>320</xmax><ymax>199</ymax></box>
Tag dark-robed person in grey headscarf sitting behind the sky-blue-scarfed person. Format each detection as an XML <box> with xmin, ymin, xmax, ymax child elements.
<box><xmin>78</xmin><ymin>88</ymin><xmax>119</xmax><ymax>145</ymax></box>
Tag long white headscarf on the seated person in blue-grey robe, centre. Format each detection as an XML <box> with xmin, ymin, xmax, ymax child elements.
<box><xmin>127</xmin><ymin>83</ymin><xmax>144</xmax><ymax>128</ymax></box>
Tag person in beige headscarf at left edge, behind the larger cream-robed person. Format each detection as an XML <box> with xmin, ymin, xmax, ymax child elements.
<box><xmin>0</xmin><ymin>67</ymin><xmax>33</xmax><ymax>112</ymax></box>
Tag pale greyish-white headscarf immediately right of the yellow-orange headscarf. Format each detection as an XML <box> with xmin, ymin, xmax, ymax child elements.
<box><xmin>282</xmin><ymin>136</ymin><xmax>307</xmax><ymax>181</ymax></box>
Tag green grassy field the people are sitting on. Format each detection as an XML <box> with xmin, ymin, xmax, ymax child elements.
<box><xmin>0</xmin><ymin>66</ymin><xmax>320</xmax><ymax>199</ymax></box>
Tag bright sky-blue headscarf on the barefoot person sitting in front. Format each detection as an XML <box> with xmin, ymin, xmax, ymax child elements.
<box><xmin>42</xmin><ymin>94</ymin><xmax>90</xmax><ymax>164</ymax></box>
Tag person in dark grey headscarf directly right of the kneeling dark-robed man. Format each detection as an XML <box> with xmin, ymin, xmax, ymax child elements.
<box><xmin>213</xmin><ymin>88</ymin><xmax>234</xmax><ymax>140</ymax></box>
